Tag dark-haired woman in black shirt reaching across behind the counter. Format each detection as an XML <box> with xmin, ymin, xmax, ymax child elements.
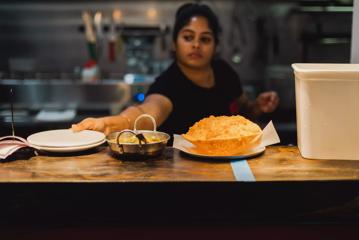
<box><xmin>72</xmin><ymin>3</ymin><xmax>279</xmax><ymax>134</ymax></box>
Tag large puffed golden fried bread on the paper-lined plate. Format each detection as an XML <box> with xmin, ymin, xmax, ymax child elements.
<box><xmin>182</xmin><ymin>115</ymin><xmax>262</xmax><ymax>156</ymax></box>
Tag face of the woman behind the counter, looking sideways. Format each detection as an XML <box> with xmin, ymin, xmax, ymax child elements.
<box><xmin>173</xmin><ymin>16</ymin><xmax>216</xmax><ymax>68</ymax></box>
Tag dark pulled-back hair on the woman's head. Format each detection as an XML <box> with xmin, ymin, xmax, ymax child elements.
<box><xmin>172</xmin><ymin>3</ymin><xmax>221</xmax><ymax>44</ymax></box>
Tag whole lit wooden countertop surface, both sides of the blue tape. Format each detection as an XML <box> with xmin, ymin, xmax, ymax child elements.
<box><xmin>0</xmin><ymin>146</ymin><xmax>359</xmax><ymax>183</ymax></box>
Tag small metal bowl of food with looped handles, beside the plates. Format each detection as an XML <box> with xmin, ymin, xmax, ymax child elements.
<box><xmin>106</xmin><ymin>114</ymin><xmax>170</xmax><ymax>157</ymax></box>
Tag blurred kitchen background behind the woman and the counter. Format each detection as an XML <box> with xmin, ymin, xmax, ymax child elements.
<box><xmin>0</xmin><ymin>0</ymin><xmax>353</xmax><ymax>144</ymax></box>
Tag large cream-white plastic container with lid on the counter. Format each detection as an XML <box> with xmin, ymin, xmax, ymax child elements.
<box><xmin>292</xmin><ymin>63</ymin><xmax>359</xmax><ymax>160</ymax></box>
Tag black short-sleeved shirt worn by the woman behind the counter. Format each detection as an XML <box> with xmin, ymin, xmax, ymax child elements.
<box><xmin>147</xmin><ymin>60</ymin><xmax>242</xmax><ymax>134</ymax></box>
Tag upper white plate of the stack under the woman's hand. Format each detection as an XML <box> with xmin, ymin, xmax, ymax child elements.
<box><xmin>27</xmin><ymin>129</ymin><xmax>105</xmax><ymax>148</ymax></box>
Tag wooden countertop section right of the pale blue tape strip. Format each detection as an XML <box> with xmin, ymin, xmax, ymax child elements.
<box><xmin>248</xmin><ymin>146</ymin><xmax>359</xmax><ymax>181</ymax></box>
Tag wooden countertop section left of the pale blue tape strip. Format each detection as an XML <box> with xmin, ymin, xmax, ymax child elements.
<box><xmin>0</xmin><ymin>147</ymin><xmax>234</xmax><ymax>182</ymax></box>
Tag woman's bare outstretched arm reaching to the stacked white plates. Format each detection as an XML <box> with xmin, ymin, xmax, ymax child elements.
<box><xmin>71</xmin><ymin>94</ymin><xmax>173</xmax><ymax>134</ymax></box>
